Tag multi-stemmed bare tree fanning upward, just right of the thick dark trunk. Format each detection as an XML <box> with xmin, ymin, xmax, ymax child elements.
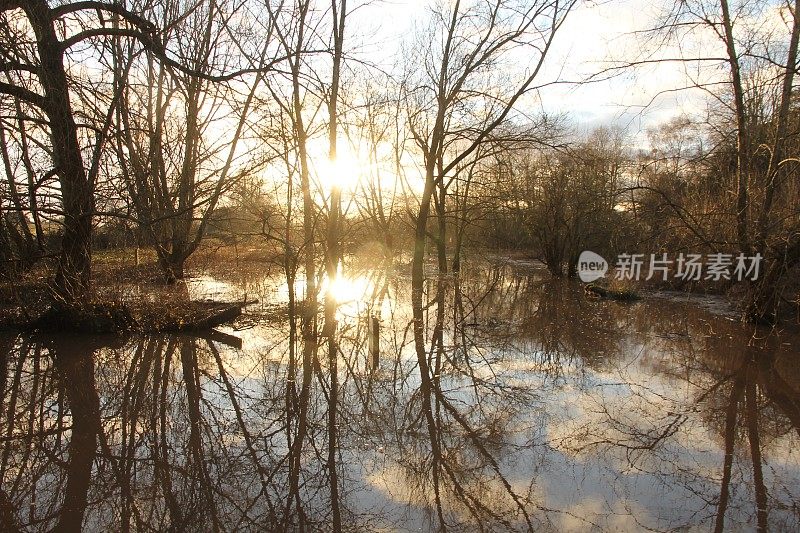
<box><xmin>114</xmin><ymin>2</ymin><xmax>272</xmax><ymax>283</ymax></box>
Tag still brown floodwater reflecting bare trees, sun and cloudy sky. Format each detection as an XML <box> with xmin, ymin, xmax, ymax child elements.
<box><xmin>0</xmin><ymin>256</ymin><xmax>800</xmax><ymax>531</ymax></box>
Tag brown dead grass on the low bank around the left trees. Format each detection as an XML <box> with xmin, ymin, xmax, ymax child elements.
<box><xmin>0</xmin><ymin>239</ymin><xmax>278</xmax><ymax>333</ymax></box>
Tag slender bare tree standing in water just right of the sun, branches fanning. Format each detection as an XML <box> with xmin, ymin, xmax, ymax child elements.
<box><xmin>404</xmin><ymin>0</ymin><xmax>574</xmax><ymax>416</ymax></box>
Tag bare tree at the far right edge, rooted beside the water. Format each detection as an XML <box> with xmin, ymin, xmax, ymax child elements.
<box><xmin>626</xmin><ymin>0</ymin><xmax>800</xmax><ymax>323</ymax></box>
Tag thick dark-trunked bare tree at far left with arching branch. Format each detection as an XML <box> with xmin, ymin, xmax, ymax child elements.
<box><xmin>0</xmin><ymin>0</ymin><xmax>176</xmax><ymax>301</ymax></box>
